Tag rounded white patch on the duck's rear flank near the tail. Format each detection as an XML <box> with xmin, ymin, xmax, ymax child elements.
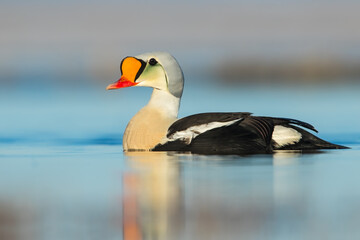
<box><xmin>272</xmin><ymin>125</ymin><xmax>302</xmax><ymax>147</ymax></box>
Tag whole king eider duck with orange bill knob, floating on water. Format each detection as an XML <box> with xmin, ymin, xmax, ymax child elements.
<box><xmin>107</xmin><ymin>52</ymin><xmax>346</xmax><ymax>154</ymax></box>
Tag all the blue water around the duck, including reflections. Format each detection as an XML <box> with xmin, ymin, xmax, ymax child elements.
<box><xmin>0</xmin><ymin>82</ymin><xmax>360</xmax><ymax>240</ymax></box>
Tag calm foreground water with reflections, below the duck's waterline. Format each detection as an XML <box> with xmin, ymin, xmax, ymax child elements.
<box><xmin>0</xmin><ymin>145</ymin><xmax>360</xmax><ymax>240</ymax></box>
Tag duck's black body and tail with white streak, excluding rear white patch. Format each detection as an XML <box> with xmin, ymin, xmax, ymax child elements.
<box><xmin>153</xmin><ymin>112</ymin><xmax>347</xmax><ymax>154</ymax></box>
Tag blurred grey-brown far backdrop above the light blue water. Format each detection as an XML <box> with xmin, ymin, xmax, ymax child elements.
<box><xmin>0</xmin><ymin>0</ymin><xmax>360</xmax><ymax>84</ymax></box>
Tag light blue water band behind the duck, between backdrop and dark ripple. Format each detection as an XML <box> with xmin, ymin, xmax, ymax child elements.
<box><xmin>0</xmin><ymin>79</ymin><xmax>360</xmax><ymax>143</ymax></box>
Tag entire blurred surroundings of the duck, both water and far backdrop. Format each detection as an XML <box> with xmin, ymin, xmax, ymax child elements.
<box><xmin>0</xmin><ymin>0</ymin><xmax>360</xmax><ymax>240</ymax></box>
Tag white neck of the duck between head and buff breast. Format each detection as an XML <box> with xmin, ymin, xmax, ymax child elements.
<box><xmin>145</xmin><ymin>89</ymin><xmax>180</xmax><ymax>118</ymax></box>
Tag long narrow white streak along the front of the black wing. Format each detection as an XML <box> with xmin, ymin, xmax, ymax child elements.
<box><xmin>163</xmin><ymin>118</ymin><xmax>243</xmax><ymax>145</ymax></box>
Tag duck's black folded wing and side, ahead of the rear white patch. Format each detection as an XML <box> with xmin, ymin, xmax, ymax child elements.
<box><xmin>153</xmin><ymin>112</ymin><xmax>274</xmax><ymax>154</ymax></box>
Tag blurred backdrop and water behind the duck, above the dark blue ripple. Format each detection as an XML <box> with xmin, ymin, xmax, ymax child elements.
<box><xmin>0</xmin><ymin>0</ymin><xmax>360</xmax><ymax>141</ymax></box>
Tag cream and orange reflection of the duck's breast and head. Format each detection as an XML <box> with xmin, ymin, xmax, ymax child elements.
<box><xmin>123</xmin><ymin>152</ymin><xmax>181</xmax><ymax>240</ymax></box>
